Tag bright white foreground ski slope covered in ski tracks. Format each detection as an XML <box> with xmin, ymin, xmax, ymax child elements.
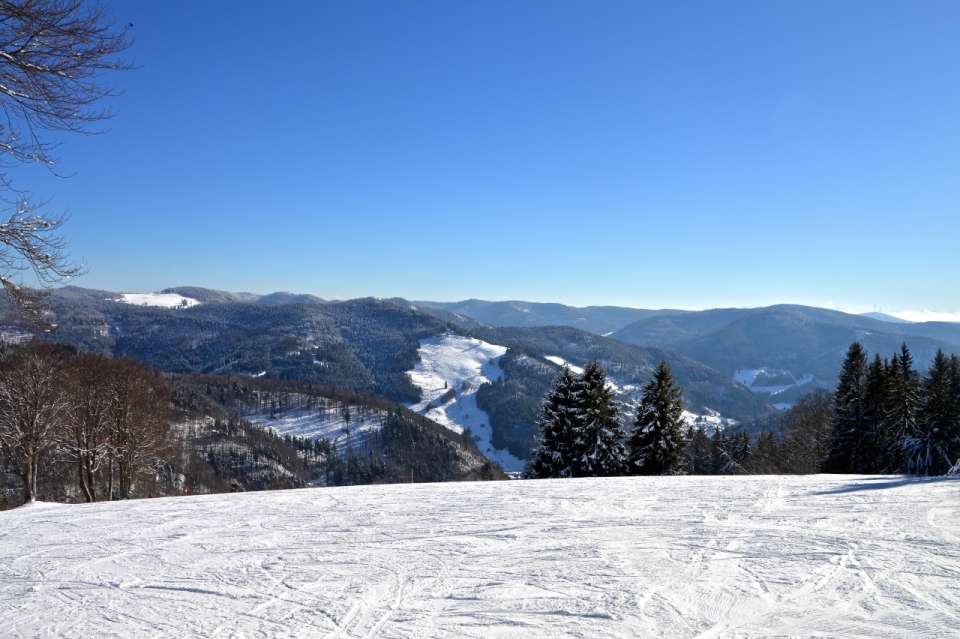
<box><xmin>0</xmin><ymin>476</ymin><xmax>960</xmax><ymax>639</ymax></box>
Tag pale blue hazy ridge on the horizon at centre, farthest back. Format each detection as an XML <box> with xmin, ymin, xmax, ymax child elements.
<box><xmin>413</xmin><ymin>300</ymin><xmax>687</xmax><ymax>335</ymax></box>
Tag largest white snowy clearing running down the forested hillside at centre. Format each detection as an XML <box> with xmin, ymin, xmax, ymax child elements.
<box><xmin>408</xmin><ymin>333</ymin><xmax>523</xmax><ymax>472</ymax></box>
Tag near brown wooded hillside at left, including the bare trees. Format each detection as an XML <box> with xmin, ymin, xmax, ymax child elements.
<box><xmin>0</xmin><ymin>343</ymin><xmax>505</xmax><ymax>509</ymax></box>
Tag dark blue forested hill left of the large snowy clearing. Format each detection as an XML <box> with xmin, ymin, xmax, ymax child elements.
<box><xmin>39</xmin><ymin>287</ymin><xmax>450</xmax><ymax>402</ymax></box>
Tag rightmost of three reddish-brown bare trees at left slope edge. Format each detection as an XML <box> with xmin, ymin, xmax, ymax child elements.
<box><xmin>108</xmin><ymin>357</ymin><xmax>170</xmax><ymax>499</ymax></box>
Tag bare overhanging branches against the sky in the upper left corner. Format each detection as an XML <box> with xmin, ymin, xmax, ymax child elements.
<box><xmin>0</xmin><ymin>0</ymin><xmax>132</xmax><ymax>325</ymax></box>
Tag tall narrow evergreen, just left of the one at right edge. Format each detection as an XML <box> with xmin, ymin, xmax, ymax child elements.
<box><xmin>880</xmin><ymin>343</ymin><xmax>920</xmax><ymax>473</ymax></box>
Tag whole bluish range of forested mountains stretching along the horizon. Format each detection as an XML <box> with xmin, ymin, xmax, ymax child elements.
<box><xmin>18</xmin><ymin>287</ymin><xmax>960</xmax><ymax>457</ymax></box>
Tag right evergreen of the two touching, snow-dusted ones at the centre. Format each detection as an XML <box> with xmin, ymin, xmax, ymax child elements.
<box><xmin>571</xmin><ymin>360</ymin><xmax>627</xmax><ymax>477</ymax></box>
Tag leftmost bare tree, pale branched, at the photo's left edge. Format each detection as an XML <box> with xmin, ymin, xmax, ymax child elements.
<box><xmin>0</xmin><ymin>345</ymin><xmax>69</xmax><ymax>503</ymax></box>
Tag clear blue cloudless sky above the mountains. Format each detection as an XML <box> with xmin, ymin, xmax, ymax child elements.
<box><xmin>14</xmin><ymin>1</ymin><xmax>960</xmax><ymax>311</ymax></box>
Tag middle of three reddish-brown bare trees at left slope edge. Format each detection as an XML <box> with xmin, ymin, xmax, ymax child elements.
<box><xmin>61</xmin><ymin>353</ymin><xmax>113</xmax><ymax>502</ymax></box>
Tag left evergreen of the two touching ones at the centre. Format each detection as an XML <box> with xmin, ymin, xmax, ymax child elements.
<box><xmin>523</xmin><ymin>366</ymin><xmax>581</xmax><ymax>479</ymax></box>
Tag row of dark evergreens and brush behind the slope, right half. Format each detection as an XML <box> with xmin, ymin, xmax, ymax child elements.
<box><xmin>525</xmin><ymin>342</ymin><xmax>960</xmax><ymax>477</ymax></box>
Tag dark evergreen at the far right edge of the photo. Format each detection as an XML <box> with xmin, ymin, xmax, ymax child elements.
<box><xmin>904</xmin><ymin>350</ymin><xmax>960</xmax><ymax>475</ymax></box>
